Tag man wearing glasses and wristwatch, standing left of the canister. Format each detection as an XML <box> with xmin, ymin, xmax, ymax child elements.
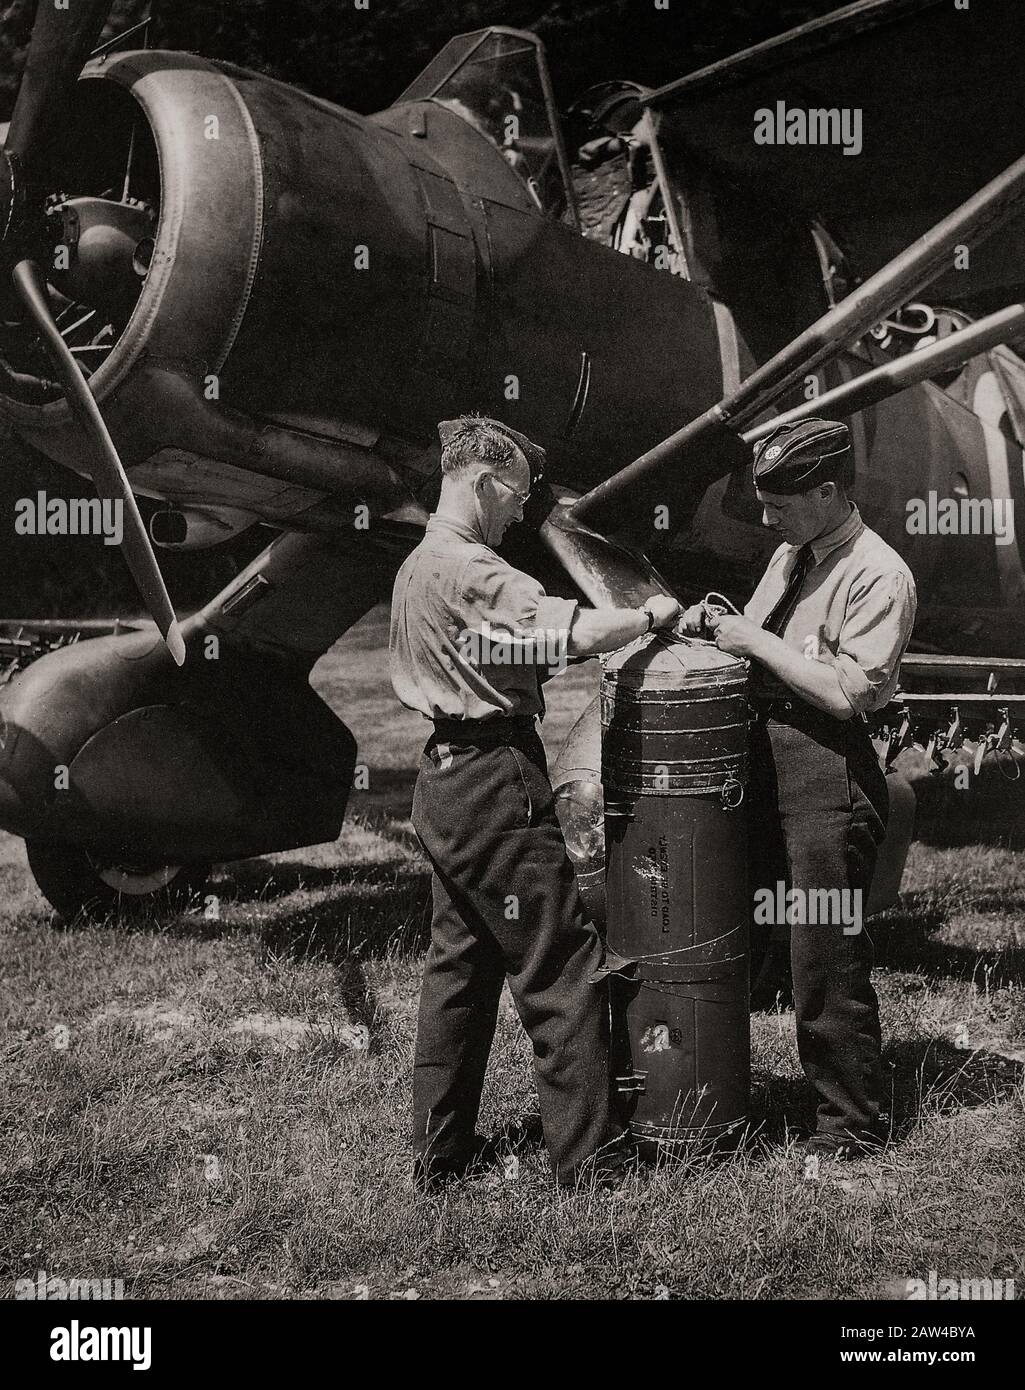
<box><xmin>389</xmin><ymin>416</ymin><xmax>680</xmax><ymax>1191</ymax></box>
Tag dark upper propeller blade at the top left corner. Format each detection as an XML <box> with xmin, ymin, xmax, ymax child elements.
<box><xmin>6</xmin><ymin>0</ymin><xmax>111</xmax><ymax>161</ymax></box>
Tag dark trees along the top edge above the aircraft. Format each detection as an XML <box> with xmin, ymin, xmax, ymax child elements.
<box><xmin>0</xmin><ymin>0</ymin><xmax>856</xmax><ymax>113</ymax></box>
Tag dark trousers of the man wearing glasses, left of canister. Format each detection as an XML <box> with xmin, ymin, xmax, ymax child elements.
<box><xmin>413</xmin><ymin>720</ymin><xmax>622</xmax><ymax>1183</ymax></box>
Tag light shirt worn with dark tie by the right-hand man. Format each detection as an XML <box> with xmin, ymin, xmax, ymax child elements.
<box><xmin>744</xmin><ymin>505</ymin><xmax>918</xmax><ymax>714</ymax></box>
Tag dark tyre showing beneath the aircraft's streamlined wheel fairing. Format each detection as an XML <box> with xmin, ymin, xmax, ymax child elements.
<box><xmin>25</xmin><ymin>840</ymin><xmax>210</xmax><ymax>922</ymax></box>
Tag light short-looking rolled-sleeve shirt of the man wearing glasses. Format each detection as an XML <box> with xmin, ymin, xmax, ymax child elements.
<box><xmin>388</xmin><ymin>513</ymin><xmax>577</xmax><ymax>719</ymax></box>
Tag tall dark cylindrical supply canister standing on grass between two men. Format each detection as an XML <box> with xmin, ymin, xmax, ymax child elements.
<box><xmin>601</xmin><ymin>632</ymin><xmax>751</xmax><ymax>1150</ymax></box>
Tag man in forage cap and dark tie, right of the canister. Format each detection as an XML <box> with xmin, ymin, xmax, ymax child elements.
<box><xmin>684</xmin><ymin>418</ymin><xmax>915</xmax><ymax>1156</ymax></box>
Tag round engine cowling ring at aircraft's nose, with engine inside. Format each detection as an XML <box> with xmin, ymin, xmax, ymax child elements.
<box><xmin>0</xmin><ymin>53</ymin><xmax>263</xmax><ymax>473</ymax></box>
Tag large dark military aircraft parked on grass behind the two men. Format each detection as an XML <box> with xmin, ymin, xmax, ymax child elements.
<box><xmin>0</xmin><ymin>0</ymin><xmax>1025</xmax><ymax>913</ymax></box>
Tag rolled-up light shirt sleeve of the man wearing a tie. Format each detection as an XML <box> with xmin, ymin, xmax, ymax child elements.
<box><xmin>833</xmin><ymin>573</ymin><xmax>917</xmax><ymax>714</ymax></box>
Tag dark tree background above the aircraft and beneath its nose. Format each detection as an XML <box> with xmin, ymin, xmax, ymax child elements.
<box><xmin>0</xmin><ymin>0</ymin><xmax>840</xmax><ymax>617</ymax></box>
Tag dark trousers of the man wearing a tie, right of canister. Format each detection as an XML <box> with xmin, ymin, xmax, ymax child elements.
<box><xmin>750</xmin><ymin>701</ymin><xmax>889</xmax><ymax>1134</ymax></box>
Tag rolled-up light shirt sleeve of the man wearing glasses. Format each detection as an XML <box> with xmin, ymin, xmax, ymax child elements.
<box><xmin>462</xmin><ymin>556</ymin><xmax>577</xmax><ymax>666</ymax></box>
